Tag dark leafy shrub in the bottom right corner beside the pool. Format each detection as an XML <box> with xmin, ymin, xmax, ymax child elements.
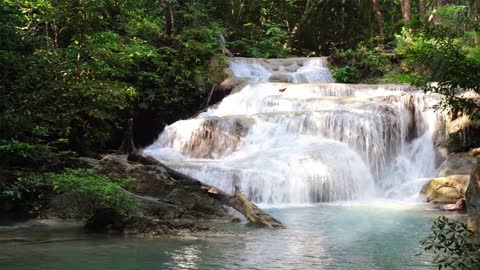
<box><xmin>420</xmin><ymin>217</ymin><xmax>480</xmax><ymax>270</ymax></box>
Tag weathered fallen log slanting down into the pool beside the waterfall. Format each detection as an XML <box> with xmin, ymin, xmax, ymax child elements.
<box><xmin>128</xmin><ymin>151</ymin><xmax>285</xmax><ymax>228</ymax></box>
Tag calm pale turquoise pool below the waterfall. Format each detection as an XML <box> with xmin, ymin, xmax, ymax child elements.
<box><xmin>0</xmin><ymin>203</ymin><xmax>462</xmax><ymax>270</ymax></box>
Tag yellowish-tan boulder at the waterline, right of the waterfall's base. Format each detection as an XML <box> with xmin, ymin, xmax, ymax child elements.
<box><xmin>420</xmin><ymin>175</ymin><xmax>469</xmax><ymax>204</ymax></box>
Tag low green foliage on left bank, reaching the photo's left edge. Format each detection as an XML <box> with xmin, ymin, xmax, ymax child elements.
<box><xmin>0</xmin><ymin>169</ymin><xmax>139</xmax><ymax>220</ymax></box>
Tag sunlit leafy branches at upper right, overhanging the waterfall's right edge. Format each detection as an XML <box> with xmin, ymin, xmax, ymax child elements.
<box><xmin>397</xmin><ymin>6</ymin><xmax>480</xmax><ymax>118</ymax></box>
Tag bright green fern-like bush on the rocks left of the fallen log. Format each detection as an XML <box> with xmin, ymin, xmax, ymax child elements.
<box><xmin>46</xmin><ymin>169</ymin><xmax>138</xmax><ymax>220</ymax></box>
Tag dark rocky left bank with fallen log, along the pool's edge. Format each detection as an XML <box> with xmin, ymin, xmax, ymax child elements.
<box><xmin>0</xmin><ymin>152</ymin><xmax>284</xmax><ymax>237</ymax></box>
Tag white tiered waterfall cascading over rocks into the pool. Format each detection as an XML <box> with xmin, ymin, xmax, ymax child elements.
<box><xmin>145</xmin><ymin>58</ymin><xmax>443</xmax><ymax>204</ymax></box>
